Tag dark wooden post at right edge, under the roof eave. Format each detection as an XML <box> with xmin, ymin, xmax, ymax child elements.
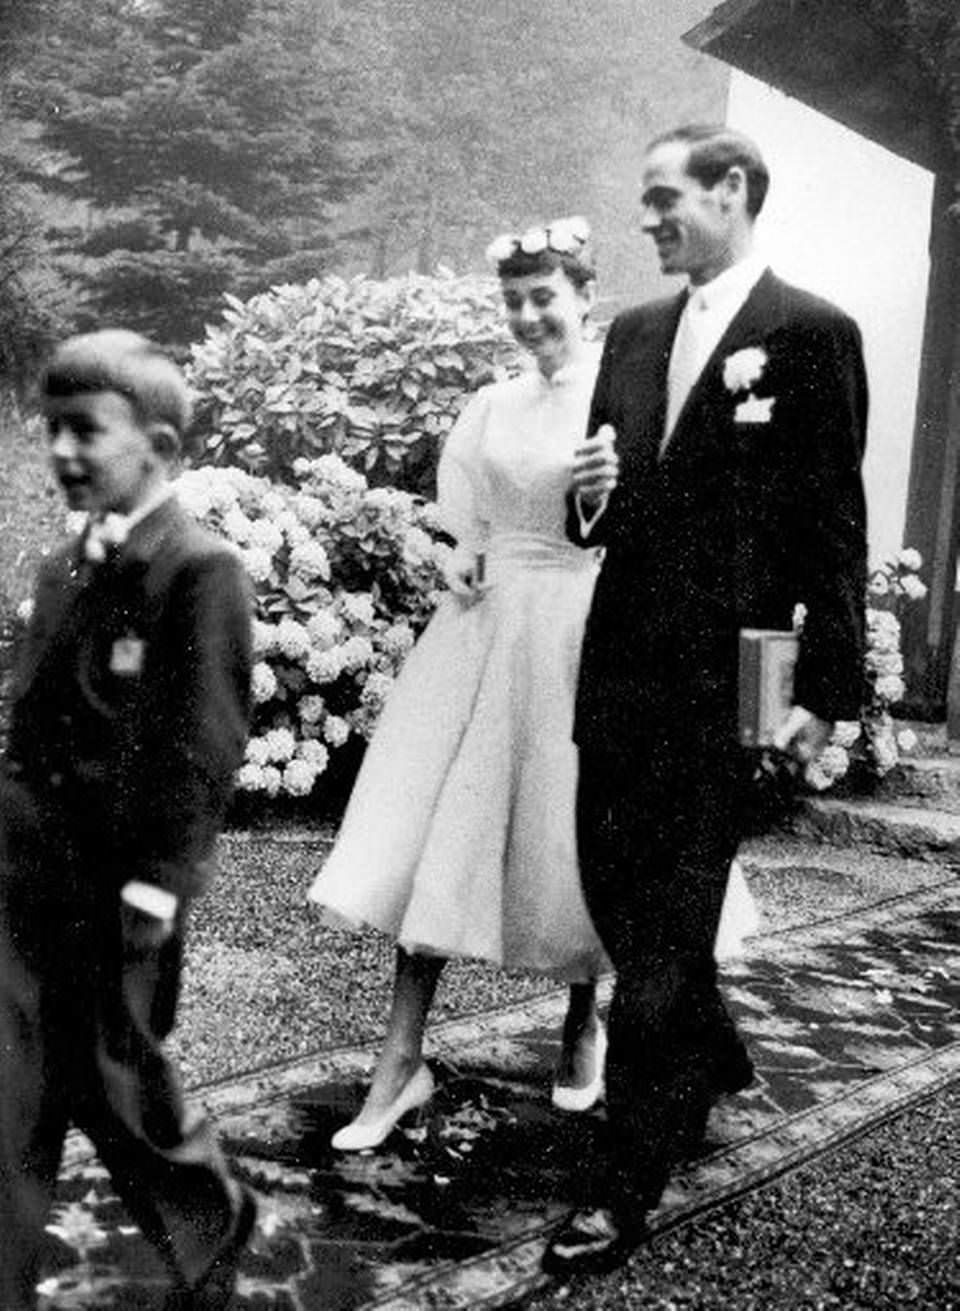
<box><xmin>902</xmin><ymin>173</ymin><xmax>960</xmax><ymax>739</ymax></box>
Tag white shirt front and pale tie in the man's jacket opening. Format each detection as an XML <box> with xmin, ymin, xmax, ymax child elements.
<box><xmin>660</xmin><ymin>254</ymin><xmax>766</xmax><ymax>454</ymax></box>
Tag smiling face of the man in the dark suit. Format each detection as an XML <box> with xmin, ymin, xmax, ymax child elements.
<box><xmin>641</xmin><ymin>142</ymin><xmax>740</xmax><ymax>283</ymax></box>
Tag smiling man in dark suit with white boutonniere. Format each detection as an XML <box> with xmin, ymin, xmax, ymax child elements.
<box><xmin>544</xmin><ymin>127</ymin><xmax>867</xmax><ymax>1274</ymax></box>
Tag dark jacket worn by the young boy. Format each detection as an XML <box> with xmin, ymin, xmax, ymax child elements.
<box><xmin>7</xmin><ymin>497</ymin><xmax>250</xmax><ymax>897</ymax></box>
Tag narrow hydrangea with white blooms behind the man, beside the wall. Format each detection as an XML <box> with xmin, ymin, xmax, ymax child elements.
<box><xmin>805</xmin><ymin>547</ymin><xmax>927</xmax><ymax>791</ymax></box>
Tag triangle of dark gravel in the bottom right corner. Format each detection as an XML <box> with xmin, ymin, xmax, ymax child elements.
<box><xmin>525</xmin><ymin>1086</ymin><xmax>960</xmax><ymax>1311</ymax></box>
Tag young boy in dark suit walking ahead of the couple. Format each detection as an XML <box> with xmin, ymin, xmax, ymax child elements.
<box><xmin>0</xmin><ymin>330</ymin><xmax>256</xmax><ymax>1311</ymax></box>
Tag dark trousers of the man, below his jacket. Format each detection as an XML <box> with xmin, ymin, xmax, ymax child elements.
<box><xmin>577</xmin><ymin>722</ymin><xmax>750</xmax><ymax>1213</ymax></box>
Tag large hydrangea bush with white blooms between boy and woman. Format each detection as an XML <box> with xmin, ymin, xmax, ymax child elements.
<box><xmin>177</xmin><ymin>455</ymin><xmax>449</xmax><ymax>798</ymax></box>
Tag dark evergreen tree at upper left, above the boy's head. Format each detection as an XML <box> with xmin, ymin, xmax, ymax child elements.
<box><xmin>6</xmin><ymin>0</ymin><xmax>367</xmax><ymax>342</ymax></box>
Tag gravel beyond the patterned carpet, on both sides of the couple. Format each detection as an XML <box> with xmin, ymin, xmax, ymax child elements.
<box><xmin>172</xmin><ymin>827</ymin><xmax>943</xmax><ymax>1087</ymax></box>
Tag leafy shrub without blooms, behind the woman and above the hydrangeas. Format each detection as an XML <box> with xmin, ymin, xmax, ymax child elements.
<box><xmin>189</xmin><ymin>273</ymin><xmax>518</xmax><ymax>496</ymax></box>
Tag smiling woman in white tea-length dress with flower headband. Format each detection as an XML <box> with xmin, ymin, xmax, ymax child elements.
<box><xmin>310</xmin><ymin>219</ymin><xmax>751</xmax><ymax>1151</ymax></box>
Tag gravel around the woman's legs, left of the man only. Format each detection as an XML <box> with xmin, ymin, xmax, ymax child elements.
<box><xmin>170</xmin><ymin>830</ymin><xmax>556</xmax><ymax>1087</ymax></box>
